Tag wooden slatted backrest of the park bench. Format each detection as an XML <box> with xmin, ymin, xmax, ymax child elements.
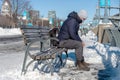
<box><xmin>20</xmin><ymin>25</ymin><xmax>50</xmax><ymax>45</ymax></box>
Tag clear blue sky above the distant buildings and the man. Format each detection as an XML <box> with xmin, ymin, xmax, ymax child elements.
<box><xmin>31</xmin><ymin>0</ymin><xmax>118</xmax><ymax>21</ymax></box>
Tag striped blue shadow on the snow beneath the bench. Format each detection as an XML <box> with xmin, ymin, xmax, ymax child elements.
<box><xmin>33</xmin><ymin>52</ymin><xmax>76</xmax><ymax>73</ymax></box>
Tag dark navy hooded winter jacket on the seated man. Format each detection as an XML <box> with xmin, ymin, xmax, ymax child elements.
<box><xmin>58</xmin><ymin>11</ymin><xmax>82</xmax><ymax>42</ymax></box>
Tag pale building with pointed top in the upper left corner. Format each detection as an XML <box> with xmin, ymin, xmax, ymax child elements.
<box><xmin>1</xmin><ymin>0</ymin><xmax>12</xmax><ymax>17</ymax></box>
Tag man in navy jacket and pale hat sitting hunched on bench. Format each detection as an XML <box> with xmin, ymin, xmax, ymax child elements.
<box><xmin>58</xmin><ymin>10</ymin><xmax>90</xmax><ymax>71</ymax></box>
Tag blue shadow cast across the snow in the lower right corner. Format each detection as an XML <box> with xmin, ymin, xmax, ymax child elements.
<box><xmin>87</xmin><ymin>44</ymin><xmax>120</xmax><ymax>80</ymax></box>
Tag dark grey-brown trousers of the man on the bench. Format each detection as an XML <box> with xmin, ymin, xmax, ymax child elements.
<box><xmin>59</xmin><ymin>39</ymin><xmax>84</xmax><ymax>61</ymax></box>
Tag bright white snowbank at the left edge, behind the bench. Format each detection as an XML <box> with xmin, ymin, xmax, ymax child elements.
<box><xmin>0</xmin><ymin>27</ymin><xmax>21</xmax><ymax>36</ymax></box>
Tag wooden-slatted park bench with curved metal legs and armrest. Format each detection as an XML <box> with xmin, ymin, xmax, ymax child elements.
<box><xmin>20</xmin><ymin>25</ymin><xmax>66</xmax><ymax>74</ymax></box>
